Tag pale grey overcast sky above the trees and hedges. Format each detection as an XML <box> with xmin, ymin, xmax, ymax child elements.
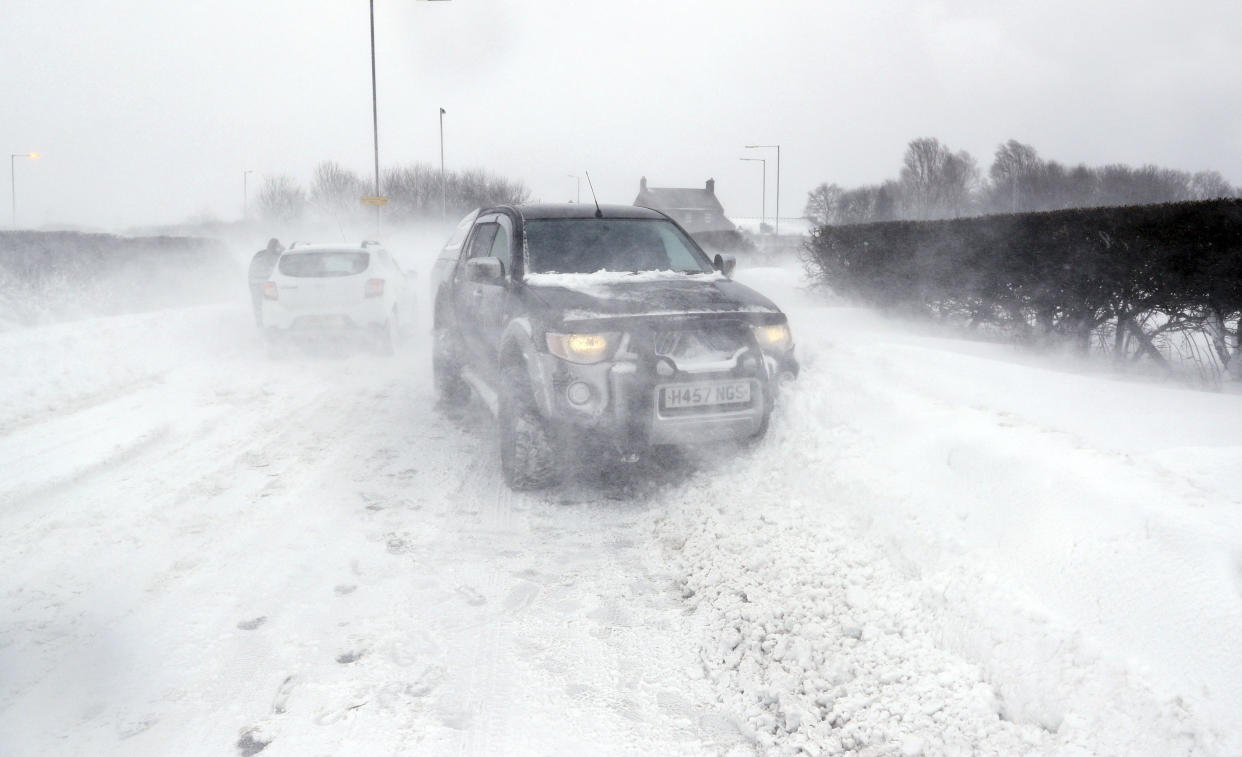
<box><xmin>0</xmin><ymin>0</ymin><xmax>1242</xmax><ymax>228</ymax></box>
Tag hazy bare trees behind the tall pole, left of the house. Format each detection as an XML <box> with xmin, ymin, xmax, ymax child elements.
<box><xmin>257</xmin><ymin>160</ymin><xmax>530</xmax><ymax>222</ymax></box>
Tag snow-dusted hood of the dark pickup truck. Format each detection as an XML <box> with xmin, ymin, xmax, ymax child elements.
<box><xmin>524</xmin><ymin>271</ymin><xmax>780</xmax><ymax>320</ymax></box>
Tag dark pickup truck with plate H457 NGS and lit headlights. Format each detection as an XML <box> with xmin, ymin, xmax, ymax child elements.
<box><xmin>432</xmin><ymin>204</ymin><xmax>797</xmax><ymax>489</ymax></box>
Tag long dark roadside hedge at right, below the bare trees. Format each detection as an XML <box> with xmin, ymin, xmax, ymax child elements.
<box><xmin>807</xmin><ymin>199</ymin><xmax>1242</xmax><ymax>377</ymax></box>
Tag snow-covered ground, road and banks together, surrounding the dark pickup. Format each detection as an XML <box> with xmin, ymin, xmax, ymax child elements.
<box><xmin>0</xmin><ymin>260</ymin><xmax>1242</xmax><ymax>757</ymax></box>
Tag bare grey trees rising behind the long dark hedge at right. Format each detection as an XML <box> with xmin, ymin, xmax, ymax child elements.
<box><xmin>804</xmin><ymin>138</ymin><xmax>1242</xmax><ymax>225</ymax></box>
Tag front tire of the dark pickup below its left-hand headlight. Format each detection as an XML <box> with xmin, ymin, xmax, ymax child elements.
<box><xmin>499</xmin><ymin>366</ymin><xmax>560</xmax><ymax>491</ymax></box>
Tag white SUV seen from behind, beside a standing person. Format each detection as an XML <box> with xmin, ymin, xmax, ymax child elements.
<box><xmin>263</xmin><ymin>242</ymin><xmax>414</xmax><ymax>352</ymax></box>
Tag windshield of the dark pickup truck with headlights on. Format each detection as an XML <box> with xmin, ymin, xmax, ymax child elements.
<box><xmin>525</xmin><ymin>218</ymin><xmax>713</xmax><ymax>273</ymax></box>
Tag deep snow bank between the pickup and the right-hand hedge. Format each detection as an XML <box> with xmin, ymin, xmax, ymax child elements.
<box><xmin>655</xmin><ymin>272</ymin><xmax>1242</xmax><ymax>756</ymax></box>
